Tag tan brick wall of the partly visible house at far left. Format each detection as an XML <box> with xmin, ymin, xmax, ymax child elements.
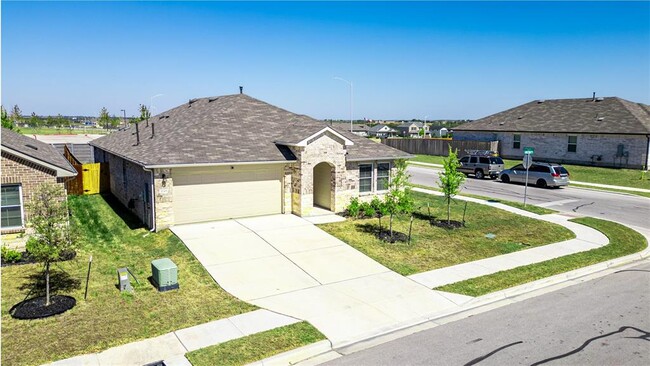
<box><xmin>0</xmin><ymin>151</ymin><xmax>65</xmax><ymax>234</ymax></box>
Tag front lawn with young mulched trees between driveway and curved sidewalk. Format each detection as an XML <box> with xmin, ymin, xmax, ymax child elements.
<box><xmin>319</xmin><ymin>192</ymin><xmax>574</xmax><ymax>276</ymax></box>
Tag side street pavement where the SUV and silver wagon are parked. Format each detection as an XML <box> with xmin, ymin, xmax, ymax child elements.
<box><xmin>408</xmin><ymin>165</ymin><xmax>650</xmax><ymax>228</ymax></box>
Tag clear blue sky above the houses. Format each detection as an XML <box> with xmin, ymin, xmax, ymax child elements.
<box><xmin>2</xmin><ymin>1</ymin><xmax>650</xmax><ymax>119</ymax></box>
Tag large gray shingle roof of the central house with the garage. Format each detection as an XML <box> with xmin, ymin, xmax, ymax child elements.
<box><xmin>90</xmin><ymin>94</ymin><xmax>410</xmax><ymax>166</ymax></box>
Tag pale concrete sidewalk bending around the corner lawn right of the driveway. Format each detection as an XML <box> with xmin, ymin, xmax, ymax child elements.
<box><xmin>408</xmin><ymin>188</ymin><xmax>609</xmax><ymax>288</ymax></box>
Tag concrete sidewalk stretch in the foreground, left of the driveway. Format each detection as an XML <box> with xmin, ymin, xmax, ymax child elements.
<box><xmin>50</xmin><ymin>309</ymin><xmax>300</xmax><ymax>366</ymax></box>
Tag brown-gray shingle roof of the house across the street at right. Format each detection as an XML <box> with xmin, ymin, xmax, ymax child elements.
<box><xmin>454</xmin><ymin>97</ymin><xmax>650</xmax><ymax>135</ymax></box>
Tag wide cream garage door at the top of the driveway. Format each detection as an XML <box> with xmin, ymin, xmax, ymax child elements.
<box><xmin>172</xmin><ymin>165</ymin><xmax>282</xmax><ymax>224</ymax></box>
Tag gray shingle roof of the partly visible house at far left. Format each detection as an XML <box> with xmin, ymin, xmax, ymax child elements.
<box><xmin>2</xmin><ymin>128</ymin><xmax>77</xmax><ymax>175</ymax></box>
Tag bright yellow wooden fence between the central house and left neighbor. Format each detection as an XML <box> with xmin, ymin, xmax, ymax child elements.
<box><xmin>63</xmin><ymin>146</ymin><xmax>109</xmax><ymax>195</ymax></box>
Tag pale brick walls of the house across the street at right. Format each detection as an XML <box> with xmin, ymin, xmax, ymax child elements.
<box><xmin>454</xmin><ymin>131</ymin><xmax>650</xmax><ymax>169</ymax></box>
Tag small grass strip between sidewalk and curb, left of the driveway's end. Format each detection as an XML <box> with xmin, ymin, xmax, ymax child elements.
<box><xmin>185</xmin><ymin>322</ymin><xmax>325</xmax><ymax>366</ymax></box>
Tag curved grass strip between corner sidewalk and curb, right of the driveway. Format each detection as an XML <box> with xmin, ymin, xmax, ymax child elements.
<box><xmin>436</xmin><ymin>217</ymin><xmax>648</xmax><ymax>296</ymax></box>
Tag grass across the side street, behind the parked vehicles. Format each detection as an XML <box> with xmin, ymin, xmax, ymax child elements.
<box><xmin>411</xmin><ymin>155</ymin><xmax>650</xmax><ymax>189</ymax></box>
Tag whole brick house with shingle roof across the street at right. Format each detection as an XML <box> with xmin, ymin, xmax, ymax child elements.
<box><xmin>454</xmin><ymin>97</ymin><xmax>650</xmax><ymax>169</ymax></box>
